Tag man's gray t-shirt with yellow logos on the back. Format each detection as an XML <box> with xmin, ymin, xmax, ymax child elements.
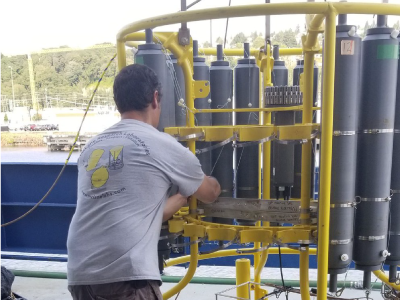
<box><xmin>67</xmin><ymin>119</ymin><xmax>204</xmax><ymax>285</ymax></box>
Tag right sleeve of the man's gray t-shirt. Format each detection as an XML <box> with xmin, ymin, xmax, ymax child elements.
<box><xmin>156</xmin><ymin>136</ymin><xmax>205</xmax><ymax>197</ymax></box>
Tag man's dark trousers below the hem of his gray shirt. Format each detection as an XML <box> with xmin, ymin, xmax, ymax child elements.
<box><xmin>68</xmin><ymin>280</ymin><xmax>162</xmax><ymax>300</ymax></box>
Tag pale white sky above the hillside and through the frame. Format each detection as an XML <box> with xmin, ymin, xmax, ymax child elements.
<box><xmin>0</xmin><ymin>0</ymin><xmax>400</xmax><ymax>55</ymax></box>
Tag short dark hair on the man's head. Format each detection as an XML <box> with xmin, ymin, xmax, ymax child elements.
<box><xmin>114</xmin><ymin>64</ymin><xmax>161</xmax><ymax>114</ymax></box>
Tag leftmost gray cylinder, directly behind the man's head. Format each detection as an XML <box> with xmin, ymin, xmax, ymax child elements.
<box><xmin>135</xmin><ymin>29</ymin><xmax>175</xmax><ymax>131</ymax></box>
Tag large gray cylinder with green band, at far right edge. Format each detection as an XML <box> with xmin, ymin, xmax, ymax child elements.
<box><xmin>353</xmin><ymin>16</ymin><xmax>399</xmax><ymax>288</ymax></box>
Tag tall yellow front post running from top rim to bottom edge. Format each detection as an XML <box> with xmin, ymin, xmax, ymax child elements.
<box><xmin>317</xmin><ymin>8</ymin><xmax>336</xmax><ymax>300</ymax></box>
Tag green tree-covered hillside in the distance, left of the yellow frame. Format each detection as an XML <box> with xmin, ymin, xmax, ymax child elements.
<box><xmin>0</xmin><ymin>46</ymin><xmax>118</xmax><ymax>99</ymax></box>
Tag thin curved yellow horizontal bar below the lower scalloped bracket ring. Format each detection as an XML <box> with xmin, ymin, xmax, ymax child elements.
<box><xmin>165</xmin><ymin>247</ymin><xmax>317</xmax><ymax>267</ymax></box>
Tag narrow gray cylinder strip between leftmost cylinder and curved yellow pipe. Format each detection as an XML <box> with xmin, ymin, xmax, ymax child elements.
<box><xmin>167</xmin><ymin>54</ymin><xmax>186</xmax><ymax>126</ymax></box>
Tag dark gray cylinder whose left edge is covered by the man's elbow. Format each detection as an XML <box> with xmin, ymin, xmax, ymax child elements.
<box><xmin>210</xmin><ymin>45</ymin><xmax>233</xmax><ymax>220</ymax></box>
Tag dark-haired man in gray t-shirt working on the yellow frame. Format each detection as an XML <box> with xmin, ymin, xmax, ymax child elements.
<box><xmin>67</xmin><ymin>65</ymin><xmax>220</xmax><ymax>300</ymax></box>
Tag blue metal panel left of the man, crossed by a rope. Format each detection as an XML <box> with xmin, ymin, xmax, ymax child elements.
<box><xmin>0</xmin><ymin>163</ymin><xmax>77</xmax><ymax>254</ymax></box>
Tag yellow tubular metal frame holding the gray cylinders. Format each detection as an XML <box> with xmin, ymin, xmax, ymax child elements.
<box><xmin>117</xmin><ymin>2</ymin><xmax>400</xmax><ymax>300</ymax></box>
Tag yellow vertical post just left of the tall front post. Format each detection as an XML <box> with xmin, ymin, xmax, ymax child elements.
<box><xmin>300</xmin><ymin>52</ymin><xmax>314</xmax><ymax>224</ymax></box>
